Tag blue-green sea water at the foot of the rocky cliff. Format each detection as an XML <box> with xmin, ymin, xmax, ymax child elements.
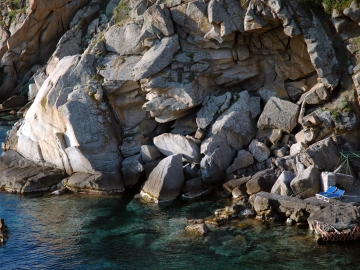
<box><xmin>0</xmin><ymin>115</ymin><xmax>360</xmax><ymax>269</ymax></box>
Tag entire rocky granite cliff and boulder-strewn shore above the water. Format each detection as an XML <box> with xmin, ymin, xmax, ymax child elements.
<box><xmin>0</xmin><ymin>0</ymin><xmax>360</xmax><ymax>243</ymax></box>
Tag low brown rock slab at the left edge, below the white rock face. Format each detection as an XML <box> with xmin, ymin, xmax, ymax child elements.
<box><xmin>0</xmin><ymin>150</ymin><xmax>66</xmax><ymax>193</ymax></box>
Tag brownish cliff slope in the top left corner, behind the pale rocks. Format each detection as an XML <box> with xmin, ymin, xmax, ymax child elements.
<box><xmin>0</xmin><ymin>0</ymin><xmax>91</xmax><ymax>99</ymax></box>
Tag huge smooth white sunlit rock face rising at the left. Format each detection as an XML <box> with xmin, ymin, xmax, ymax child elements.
<box><xmin>17</xmin><ymin>56</ymin><xmax>122</xmax><ymax>192</ymax></box>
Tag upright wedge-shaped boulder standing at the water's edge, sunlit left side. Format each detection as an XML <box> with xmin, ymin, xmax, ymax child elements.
<box><xmin>140</xmin><ymin>154</ymin><xmax>184</xmax><ymax>203</ymax></box>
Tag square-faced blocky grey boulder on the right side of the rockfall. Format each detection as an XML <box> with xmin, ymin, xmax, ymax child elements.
<box><xmin>257</xmin><ymin>97</ymin><xmax>300</xmax><ymax>133</ymax></box>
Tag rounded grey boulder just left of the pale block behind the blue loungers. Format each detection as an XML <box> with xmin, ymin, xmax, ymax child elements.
<box><xmin>290</xmin><ymin>165</ymin><xmax>321</xmax><ymax>199</ymax></box>
